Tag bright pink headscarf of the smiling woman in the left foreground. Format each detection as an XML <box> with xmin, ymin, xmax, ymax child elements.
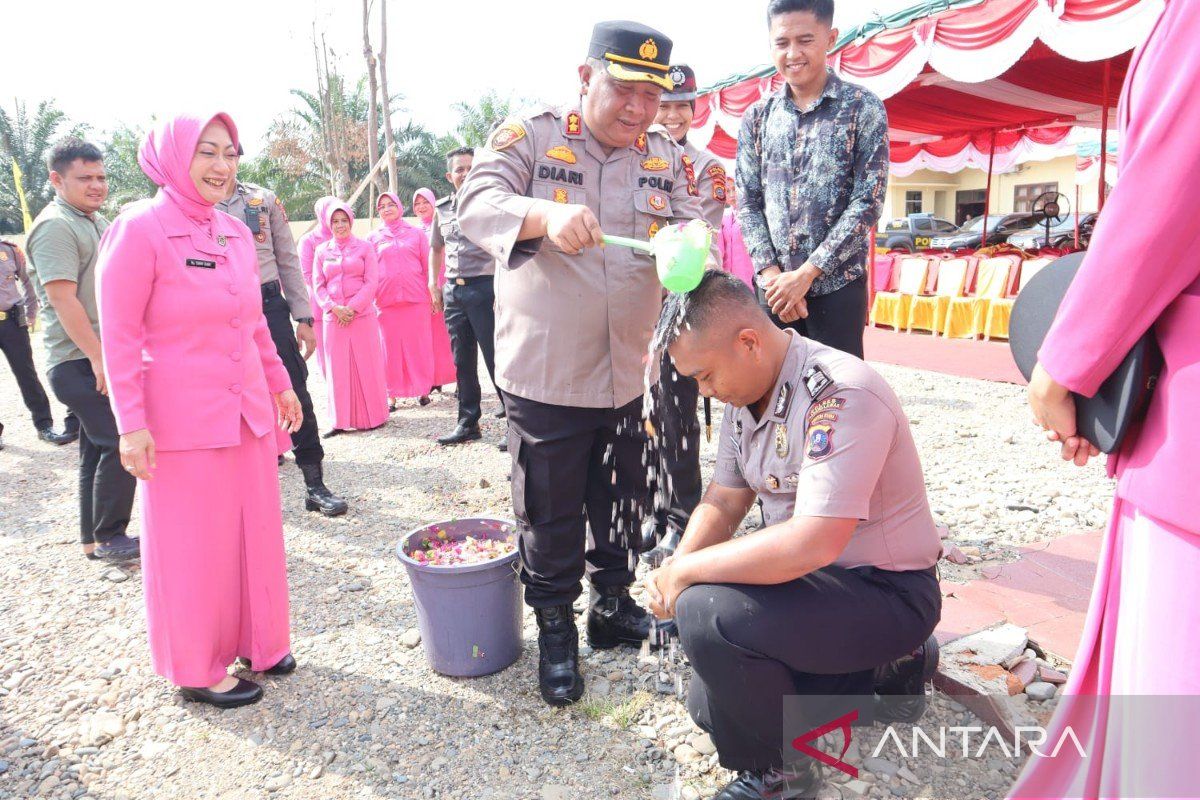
<box><xmin>138</xmin><ymin>113</ymin><xmax>238</xmax><ymax>222</ymax></box>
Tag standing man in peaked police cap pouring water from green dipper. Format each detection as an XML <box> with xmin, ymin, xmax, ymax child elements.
<box><xmin>458</xmin><ymin>22</ymin><xmax>716</xmax><ymax>705</ymax></box>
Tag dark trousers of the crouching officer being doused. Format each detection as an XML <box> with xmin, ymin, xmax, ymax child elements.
<box><xmin>676</xmin><ymin>566</ymin><xmax>942</xmax><ymax>771</ymax></box>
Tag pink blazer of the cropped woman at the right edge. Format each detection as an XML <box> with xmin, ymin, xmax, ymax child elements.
<box><xmin>1039</xmin><ymin>0</ymin><xmax>1200</xmax><ymax>533</ymax></box>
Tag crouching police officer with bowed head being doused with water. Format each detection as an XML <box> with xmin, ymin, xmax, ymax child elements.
<box><xmin>647</xmin><ymin>272</ymin><xmax>942</xmax><ymax>800</ymax></box>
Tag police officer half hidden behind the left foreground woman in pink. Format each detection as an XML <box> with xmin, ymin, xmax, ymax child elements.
<box><xmin>216</xmin><ymin>152</ymin><xmax>349</xmax><ymax>517</ymax></box>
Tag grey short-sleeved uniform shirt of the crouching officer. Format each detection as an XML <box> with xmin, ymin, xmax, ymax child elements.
<box><xmin>713</xmin><ymin>331</ymin><xmax>941</xmax><ymax>571</ymax></box>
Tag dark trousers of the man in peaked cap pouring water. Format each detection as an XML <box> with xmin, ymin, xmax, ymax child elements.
<box><xmin>504</xmin><ymin>393</ymin><xmax>649</xmax><ymax>608</ymax></box>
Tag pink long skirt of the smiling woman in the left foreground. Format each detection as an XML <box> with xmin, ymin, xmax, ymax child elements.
<box><xmin>139</xmin><ymin>421</ymin><xmax>292</xmax><ymax>686</ymax></box>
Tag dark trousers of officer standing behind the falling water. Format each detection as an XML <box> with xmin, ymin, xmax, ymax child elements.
<box><xmin>653</xmin><ymin>351</ymin><xmax>703</xmax><ymax>534</ymax></box>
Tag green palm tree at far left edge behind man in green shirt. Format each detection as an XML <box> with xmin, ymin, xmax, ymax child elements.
<box><xmin>0</xmin><ymin>100</ymin><xmax>88</xmax><ymax>233</ymax></box>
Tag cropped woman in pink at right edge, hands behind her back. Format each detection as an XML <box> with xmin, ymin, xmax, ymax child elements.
<box><xmin>1012</xmin><ymin>0</ymin><xmax>1200</xmax><ymax>798</ymax></box>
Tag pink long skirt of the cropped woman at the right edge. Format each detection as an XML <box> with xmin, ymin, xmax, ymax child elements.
<box><xmin>1009</xmin><ymin>498</ymin><xmax>1200</xmax><ymax>800</ymax></box>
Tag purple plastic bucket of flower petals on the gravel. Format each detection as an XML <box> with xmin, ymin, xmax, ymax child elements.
<box><xmin>396</xmin><ymin>517</ymin><xmax>521</xmax><ymax>678</ymax></box>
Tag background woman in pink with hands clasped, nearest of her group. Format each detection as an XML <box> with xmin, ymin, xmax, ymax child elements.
<box><xmin>312</xmin><ymin>200</ymin><xmax>388</xmax><ymax>437</ymax></box>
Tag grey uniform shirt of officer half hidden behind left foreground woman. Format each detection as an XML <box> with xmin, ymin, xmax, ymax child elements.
<box><xmin>217</xmin><ymin>181</ymin><xmax>312</xmax><ymax>319</ymax></box>
